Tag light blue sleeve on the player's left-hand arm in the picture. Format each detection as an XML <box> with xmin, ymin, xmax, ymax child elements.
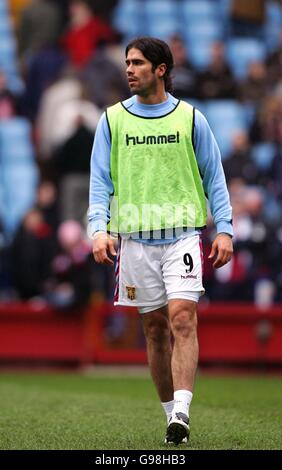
<box><xmin>88</xmin><ymin>113</ymin><xmax>114</xmax><ymax>237</ymax></box>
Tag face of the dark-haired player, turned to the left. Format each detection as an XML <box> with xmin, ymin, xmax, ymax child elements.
<box><xmin>125</xmin><ymin>48</ymin><xmax>158</xmax><ymax>96</ymax></box>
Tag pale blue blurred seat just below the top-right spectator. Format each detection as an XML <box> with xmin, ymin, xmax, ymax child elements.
<box><xmin>226</xmin><ymin>38</ymin><xmax>266</xmax><ymax>80</ymax></box>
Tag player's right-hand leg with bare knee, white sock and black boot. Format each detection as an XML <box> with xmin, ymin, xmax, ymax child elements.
<box><xmin>167</xmin><ymin>299</ymin><xmax>199</xmax><ymax>444</ymax></box>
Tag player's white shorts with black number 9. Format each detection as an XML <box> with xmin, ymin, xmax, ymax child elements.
<box><xmin>114</xmin><ymin>235</ymin><xmax>205</xmax><ymax>313</ymax></box>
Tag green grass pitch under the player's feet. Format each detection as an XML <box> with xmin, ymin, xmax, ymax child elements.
<box><xmin>0</xmin><ymin>369</ymin><xmax>282</xmax><ymax>450</ymax></box>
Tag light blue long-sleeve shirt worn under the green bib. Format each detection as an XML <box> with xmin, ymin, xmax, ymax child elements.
<box><xmin>88</xmin><ymin>93</ymin><xmax>233</xmax><ymax>244</ymax></box>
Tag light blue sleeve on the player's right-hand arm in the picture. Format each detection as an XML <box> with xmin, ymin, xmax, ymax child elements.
<box><xmin>193</xmin><ymin>109</ymin><xmax>233</xmax><ymax>236</ymax></box>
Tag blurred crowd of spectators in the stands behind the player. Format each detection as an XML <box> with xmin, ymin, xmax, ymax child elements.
<box><xmin>0</xmin><ymin>0</ymin><xmax>282</xmax><ymax>310</ymax></box>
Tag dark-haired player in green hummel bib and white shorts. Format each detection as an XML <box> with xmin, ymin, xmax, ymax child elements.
<box><xmin>88</xmin><ymin>37</ymin><xmax>233</xmax><ymax>445</ymax></box>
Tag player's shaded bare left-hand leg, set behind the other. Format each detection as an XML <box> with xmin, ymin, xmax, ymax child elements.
<box><xmin>142</xmin><ymin>306</ymin><xmax>173</xmax><ymax>403</ymax></box>
